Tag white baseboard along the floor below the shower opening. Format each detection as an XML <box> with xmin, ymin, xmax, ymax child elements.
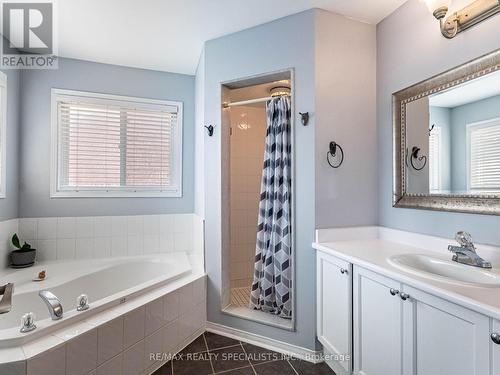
<box><xmin>207</xmin><ymin>322</ymin><xmax>323</xmax><ymax>363</ymax></box>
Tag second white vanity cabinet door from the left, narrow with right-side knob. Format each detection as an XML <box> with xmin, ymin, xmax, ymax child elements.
<box><xmin>353</xmin><ymin>266</ymin><xmax>402</xmax><ymax>375</ymax></box>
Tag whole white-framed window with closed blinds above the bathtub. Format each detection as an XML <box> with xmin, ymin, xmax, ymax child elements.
<box><xmin>51</xmin><ymin>89</ymin><xmax>182</xmax><ymax>197</ymax></box>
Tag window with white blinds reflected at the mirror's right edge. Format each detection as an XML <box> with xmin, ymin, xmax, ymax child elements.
<box><xmin>467</xmin><ymin>119</ymin><xmax>500</xmax><ymax>192</ymax></box>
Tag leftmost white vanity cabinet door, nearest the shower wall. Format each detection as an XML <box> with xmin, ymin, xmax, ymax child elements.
<box><xmin>317</xmin><ymin>252</ymin><xmax>352</xmax><ymax>375</ymax></box>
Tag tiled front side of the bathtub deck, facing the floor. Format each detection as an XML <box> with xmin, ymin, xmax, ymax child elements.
<box><xmin>0</xmin><ymin>272</ymin><xmax>206</xmax><ymax>375</ymax></box>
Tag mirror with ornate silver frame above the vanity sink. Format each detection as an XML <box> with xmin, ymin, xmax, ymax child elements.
<box><xmin>393</xmin><ymin>51</ymin><xmax>500</xmax><ymax>214</ymax></box>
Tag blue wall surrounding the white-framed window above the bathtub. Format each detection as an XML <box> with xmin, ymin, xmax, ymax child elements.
<box><xmin>19</xmin><ymin>58</ymin><xmax>194</xmax><ymax>217</ymax></box>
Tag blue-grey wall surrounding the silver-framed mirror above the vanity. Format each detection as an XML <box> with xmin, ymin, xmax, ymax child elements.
<box><xmin>377</xmin><ymin>0</ymin><xmax>500</xmax><ymax>247</ymax></box>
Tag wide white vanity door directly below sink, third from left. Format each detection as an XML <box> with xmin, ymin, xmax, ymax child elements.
<box><xmin>403</xmin><ymin>285</ymin><xmax>490</xmax><ymax>375</ymax></box>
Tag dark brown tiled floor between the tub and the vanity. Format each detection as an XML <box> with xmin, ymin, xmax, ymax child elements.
<box><xmin>153</xmin><ymin>332</ymin><xmax>335</xmax><ymax>375</ymax></box>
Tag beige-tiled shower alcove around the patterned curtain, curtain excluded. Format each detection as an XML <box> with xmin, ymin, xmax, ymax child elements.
<box><xmin>221</xmin><ymin>70</ymin><xmax>295</xmax><ymax>330</ymax></box>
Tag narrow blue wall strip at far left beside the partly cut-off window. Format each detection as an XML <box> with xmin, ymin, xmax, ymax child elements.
<box><xmin>0</xmin><ymin>70</ymin><xmax>20</xmax><ymax>221</ymax></box>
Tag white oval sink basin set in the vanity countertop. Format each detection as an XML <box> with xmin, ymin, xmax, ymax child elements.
<box><xmin>388</xmin><ymin>254</ymin><xmax>500</xmax><ymax>287</ymax></box>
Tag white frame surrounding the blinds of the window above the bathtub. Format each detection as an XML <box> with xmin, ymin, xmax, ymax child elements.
<box><xmin>50</xmin><ymin>88</ymin><xmax>183</xmax><ymax>198</ymax></box>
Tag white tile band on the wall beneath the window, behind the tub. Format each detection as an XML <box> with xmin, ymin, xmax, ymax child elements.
<box><xmin>14</xmin><ymin>214</ymin><xmax>203</xmax><ymax>261</ymax></box>
